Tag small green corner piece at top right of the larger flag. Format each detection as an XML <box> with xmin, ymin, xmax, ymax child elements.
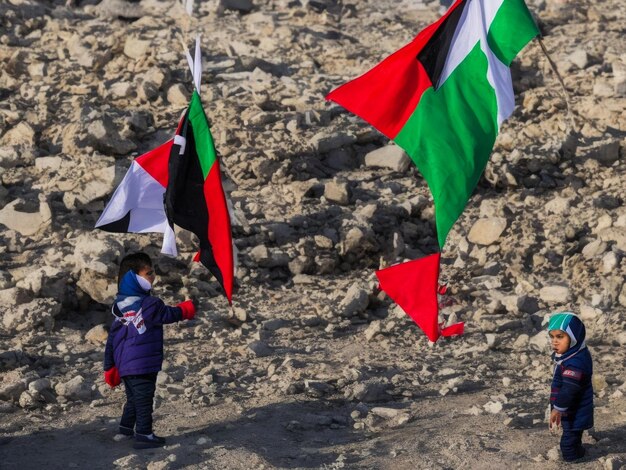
<box><xmin>487</xmin><ymin>0</ymin><xmax>539</xmax><ymax>67</ymax></box>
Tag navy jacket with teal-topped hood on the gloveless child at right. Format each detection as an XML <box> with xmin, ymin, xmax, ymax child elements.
<box><xmin>549</xmin><ymin>313</ymin><xmax>593</xmax><ymax>431</ymax></box>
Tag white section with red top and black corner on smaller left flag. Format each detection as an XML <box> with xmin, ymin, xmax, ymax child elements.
<box><xmin>96</xmin><ymin>139</ymin><xmax>177</xmax><ymax>256</ymax></box>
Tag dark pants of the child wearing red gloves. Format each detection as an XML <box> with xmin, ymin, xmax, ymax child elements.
<box><xmin>120</xmin><ymin>372</ymin><xmax>157</xmax><ymax>435</ymax></box>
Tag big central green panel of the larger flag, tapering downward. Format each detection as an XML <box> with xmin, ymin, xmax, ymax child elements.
<box><xmin>394</xmin><ymin>43</ymin><xmax>498</xmax><ymax>248</ymax></box>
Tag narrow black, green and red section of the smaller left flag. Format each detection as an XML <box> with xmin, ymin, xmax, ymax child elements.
<box><xmin>165</xmin><ymin>90</ymin><xmax>234</xmax><ymax>302</ymax></box>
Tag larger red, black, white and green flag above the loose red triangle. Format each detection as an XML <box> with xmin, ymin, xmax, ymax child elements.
<box><xmin>327</xmin><ymin>0</ymin><xmax>539</xmax><ymax>342</ymax></box>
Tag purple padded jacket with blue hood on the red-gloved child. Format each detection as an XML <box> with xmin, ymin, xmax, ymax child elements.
<box><xmin>104</xmin><ymin>271</ymin><xmax>182</xmax><ymax>377</ymax></box>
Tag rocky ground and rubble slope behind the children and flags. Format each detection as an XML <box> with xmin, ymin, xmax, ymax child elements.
<box><xmin>0</xmin><ymin>0</ymin><xmax>626</xmax><ymax>469</ymax></box>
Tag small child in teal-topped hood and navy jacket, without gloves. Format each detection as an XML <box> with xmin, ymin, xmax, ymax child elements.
<box><xmin>548</xmin><ymin>312</ymin><xmax>593</xmax><ymax>462</ymax></box>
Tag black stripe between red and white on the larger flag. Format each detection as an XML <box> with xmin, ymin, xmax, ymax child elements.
<box><xmin>417</xmin><ymin>0</ymin><xmax>471</xmax><ymax>89</ymax></box>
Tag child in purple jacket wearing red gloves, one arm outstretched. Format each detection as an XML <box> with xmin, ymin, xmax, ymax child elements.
<box><xmin>104</xmin><ymin>253</ymin><xmax>196</xmax><ymax>449</ymax></box>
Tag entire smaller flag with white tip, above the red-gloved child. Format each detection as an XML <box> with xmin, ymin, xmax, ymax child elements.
<box><xmin>96</xmin><ymin>39</ymin><xmax>234</xmax><ymax>302</ymax></box>
